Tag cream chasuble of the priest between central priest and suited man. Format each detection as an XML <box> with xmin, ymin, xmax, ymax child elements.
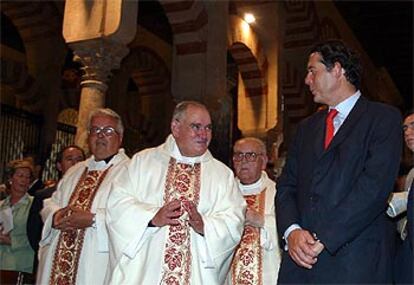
<box><xmin>226</xmin><ymin>171</ymin><xmax>281</xmax><ymax>285</ymax></box>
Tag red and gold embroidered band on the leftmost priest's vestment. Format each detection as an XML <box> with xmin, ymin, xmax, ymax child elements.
<box><xmin>49</xmin><ymin>166</ymin><xmax>112</xmax><ymax>285</ymax></box>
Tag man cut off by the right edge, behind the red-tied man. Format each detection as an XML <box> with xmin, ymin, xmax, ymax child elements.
<box><xmin>394</xmin><ymin>110</ymin><xmax>414</xmax><ymax>284</ymax></box>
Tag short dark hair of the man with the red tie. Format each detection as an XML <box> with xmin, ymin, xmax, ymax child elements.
<box><xmin>309</xmin><ymin>40</ymin><xmax>362</xmax><ymax>89</ymax></box>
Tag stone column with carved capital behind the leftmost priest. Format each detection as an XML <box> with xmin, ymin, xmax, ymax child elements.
<box><xmin>70</xmin><ymin>39</ymin><xmax>128</xmax><ymax>150</ymax></box>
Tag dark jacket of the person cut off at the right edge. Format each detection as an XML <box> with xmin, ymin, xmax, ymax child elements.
<box><xmin>394</xmin><ymin>181</ymin><xmax>414</xmax><ymax>284</ymax></box>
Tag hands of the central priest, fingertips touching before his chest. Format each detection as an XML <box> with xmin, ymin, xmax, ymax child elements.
<box><xmin>151</xmin><ymin>200</ymin><xmax>204</xmax><ymax>235</ymax></box>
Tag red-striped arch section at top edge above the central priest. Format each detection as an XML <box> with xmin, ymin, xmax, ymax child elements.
<box><xmin>160</xmin><ymin>0</ymin><xmax>208</xmax><ymax>55</ymax></box>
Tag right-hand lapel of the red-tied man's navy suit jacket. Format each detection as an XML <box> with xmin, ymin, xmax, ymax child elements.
<box><xmin>324</xmin><ymin>96</ymin><xmax>367</xmax><ymax>153</ymax></box>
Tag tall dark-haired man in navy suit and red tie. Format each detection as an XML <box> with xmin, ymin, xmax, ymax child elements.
<box><xmin>276</xmin><ymin>41</ymin><xmax>401</xmax><ymax>284</ymax></box>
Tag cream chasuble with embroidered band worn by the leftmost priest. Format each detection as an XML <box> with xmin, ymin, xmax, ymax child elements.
<box><xmin>36</xmin><ymin>150</ymin><xmax>129</xmax><ymax>285</ymax></box>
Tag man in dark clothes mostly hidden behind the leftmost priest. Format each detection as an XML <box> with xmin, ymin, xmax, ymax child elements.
<box><xmin>26</xmin><ymin>145</ymin><xmax>85</xmax><ymax>272</ymax></box>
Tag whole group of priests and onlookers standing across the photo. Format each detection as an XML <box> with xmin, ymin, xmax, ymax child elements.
<box><xmin>0</xmin><ymin>41</ymin><xmax>414</xmax><ymax>285</ymax></box>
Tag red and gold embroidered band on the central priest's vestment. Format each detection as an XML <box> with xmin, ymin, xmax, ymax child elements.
<box><xmin>161</xmin><ymin>158</ymin><xmax>201</xmax><ymax>285</ymax></box>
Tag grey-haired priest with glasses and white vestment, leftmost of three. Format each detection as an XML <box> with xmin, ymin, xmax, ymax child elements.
<box><xmin>36</xmin><ymin>109</ymin><xmax>129</xmax><ymax>285</ymax></box>
